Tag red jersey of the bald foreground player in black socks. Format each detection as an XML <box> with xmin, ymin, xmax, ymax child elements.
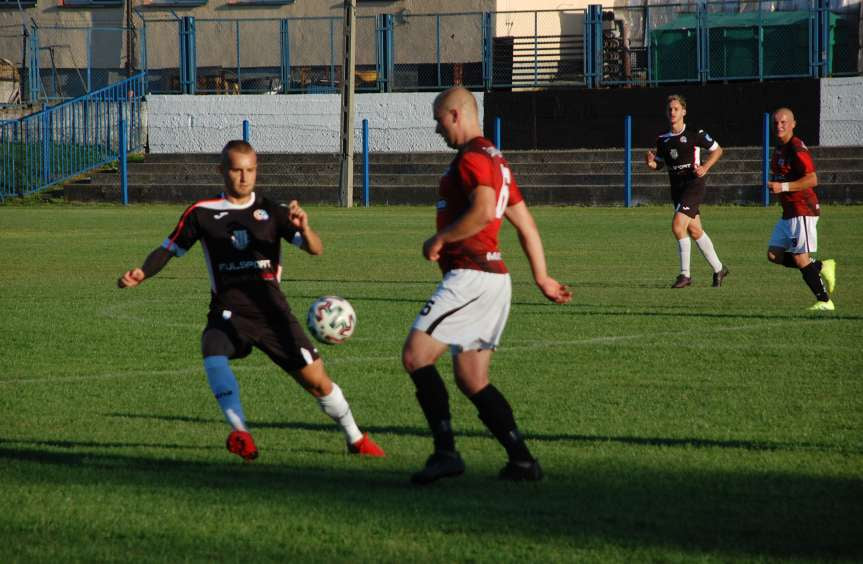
<box><xmin>437</xmin><ymin>137</ymin><xmax>524</xmax><ymax>274</ymax></box>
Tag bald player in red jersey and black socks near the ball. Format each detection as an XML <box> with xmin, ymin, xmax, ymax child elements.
<box><xmin>402</xmin><ymin>88</ymin><xmax>572</xmax><ymax>485</ymax></box>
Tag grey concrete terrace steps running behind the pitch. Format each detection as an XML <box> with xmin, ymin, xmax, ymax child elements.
<box><xmin>64</xmin><ymin>147</ymin><xmax>863</xmax><ymax>205</ymax></box>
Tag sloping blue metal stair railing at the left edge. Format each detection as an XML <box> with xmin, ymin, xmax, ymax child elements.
<box><xmin>0</xmin><ymin>73</ymin><xmax>146</xmax><ymax>200</ymax></box>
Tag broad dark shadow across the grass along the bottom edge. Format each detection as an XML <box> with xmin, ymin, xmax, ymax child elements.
<box><xmin>0</xmin><ymin>436</ymin><xmax>863</xmax><ymax>560</ymax></box>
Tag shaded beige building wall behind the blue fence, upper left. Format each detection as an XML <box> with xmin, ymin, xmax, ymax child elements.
<box><xmin>0</xmin><ymin>0</ymin><xmax>495</xmax><ymax>72</ymax></box>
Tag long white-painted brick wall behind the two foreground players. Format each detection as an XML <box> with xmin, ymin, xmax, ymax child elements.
<box><xmin>147</xmin><ymin>92</ymin><xmax>490</xmax><ymax>153</ymax></box>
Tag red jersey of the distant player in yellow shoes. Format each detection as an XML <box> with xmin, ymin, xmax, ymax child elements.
<box><xmin>770</xmin><ymin>137</ymin><xmax>821</xmax><ymax>219</ymax></box>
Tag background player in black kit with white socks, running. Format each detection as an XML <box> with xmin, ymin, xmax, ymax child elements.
<box><xmin>645</xmin><ymin>94</ymin><xmax>728</xmax><ymax>288</ymax></box>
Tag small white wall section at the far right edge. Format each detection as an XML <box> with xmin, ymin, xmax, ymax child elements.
<box><xmin>820</xmin><ymin>76</ymin><xmax>863</xmax><ymax>147</ymax></box>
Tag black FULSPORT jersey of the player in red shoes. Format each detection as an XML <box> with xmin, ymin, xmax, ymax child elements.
<box><xmin>162</xmin><ymin>194</ymin><xmax>302</xmax><ymax>314</ymax></box>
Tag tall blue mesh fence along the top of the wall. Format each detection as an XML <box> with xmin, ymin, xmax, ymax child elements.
<box><xmin>133</xmin><ymin>0</ymin><xmax>860</xmax><ymax>94</ymax></box>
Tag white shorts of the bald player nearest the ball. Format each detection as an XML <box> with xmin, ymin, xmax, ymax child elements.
<box><xmin>412</xmin><ymin>268</ymin><xmax>512</xmax><ymax>354</ymax></box>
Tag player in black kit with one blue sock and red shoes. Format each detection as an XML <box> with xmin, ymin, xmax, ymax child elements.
<box><xmin>117</xmin><ymin>141</ymin><xmax>384</xmax><ymax>460</ymax></box>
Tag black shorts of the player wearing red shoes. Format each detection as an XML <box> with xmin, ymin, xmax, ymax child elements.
<box><xmin>201</xmin><ymin>310</ymin><xmax>320</xmax><ymax>372</ymax></box>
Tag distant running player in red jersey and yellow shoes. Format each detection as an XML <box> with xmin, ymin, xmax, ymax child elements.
<box><xmin>767</xmin><ymin>108</ymin><xmax>836</xmax><ymax>311</ymax></box>
